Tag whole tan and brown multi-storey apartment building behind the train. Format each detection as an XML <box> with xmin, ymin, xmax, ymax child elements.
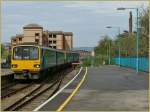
<box><xmin>11</xmin><ymin>24</ymin><xmax>73</xmax><ymax>51</ymax></box>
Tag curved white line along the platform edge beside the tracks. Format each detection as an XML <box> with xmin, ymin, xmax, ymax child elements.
<box><xmin>33</xmin><ymin>67</ymin><xmax>83</xmax><ymax>111</ymax></box>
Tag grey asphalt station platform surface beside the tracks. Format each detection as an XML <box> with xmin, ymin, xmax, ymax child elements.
<box><xmin>35</xmin><ymin>66</ymin><xmax>149</xmax><ymax>111</ymax></box>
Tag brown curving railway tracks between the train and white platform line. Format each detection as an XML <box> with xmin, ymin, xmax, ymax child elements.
<box><xmin>1</xmin><ymin>67</ymin><xmax>74</xmax><ymax>111</ymax></box>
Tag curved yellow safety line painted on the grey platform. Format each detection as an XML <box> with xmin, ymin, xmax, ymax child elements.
<box><xmin>56</xmin><ymin>67</ymin><xmax>87</xmax><ymax>111</ymax></box>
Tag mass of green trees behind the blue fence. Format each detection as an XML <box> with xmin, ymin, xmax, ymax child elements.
<box><xmin>94</xmin><ymin>8</ymin><xmax>149</xmax><ymax>64</ymax></box>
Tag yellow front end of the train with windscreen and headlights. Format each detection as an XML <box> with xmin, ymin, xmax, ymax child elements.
<box><xmin>11</xmin><ymin>45</ymin><xmax>40</xmax><ymax>79</ymax></box>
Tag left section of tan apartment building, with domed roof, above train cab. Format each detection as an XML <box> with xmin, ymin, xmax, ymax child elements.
<box><xmin>11</xmin><ymin>24</ymin><xmax>48</xmax><ymax>46</ymax></box>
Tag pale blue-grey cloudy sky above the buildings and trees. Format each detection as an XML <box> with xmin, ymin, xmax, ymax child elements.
<box><xmin>2</xmin><ymin>1</ymin><xmax>148</xmax><ymax>47</ymax></box>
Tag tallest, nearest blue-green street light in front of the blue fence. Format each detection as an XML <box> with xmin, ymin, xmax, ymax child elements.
<box><xmin>117</xmin><ymin>7</ymin><xmax>139</xmax><ymax>73</ymax></box>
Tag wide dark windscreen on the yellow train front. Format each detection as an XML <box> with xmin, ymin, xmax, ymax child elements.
<box><xmin>13</xmin><ymin>46</ymin><xmax>38</xmax><ymax>60</ymax></box>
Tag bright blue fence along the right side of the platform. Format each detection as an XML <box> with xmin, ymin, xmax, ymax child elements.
<box><xmin>113</xmin><ymin>57</ymin><xmax>149</xmax><ymax>72</ymax></box>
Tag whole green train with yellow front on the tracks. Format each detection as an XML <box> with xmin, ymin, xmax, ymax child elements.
<box><xmin>11</xmin><ymin>45</ymin><xmax>79</xmax><ymax>79</ymax></box>
